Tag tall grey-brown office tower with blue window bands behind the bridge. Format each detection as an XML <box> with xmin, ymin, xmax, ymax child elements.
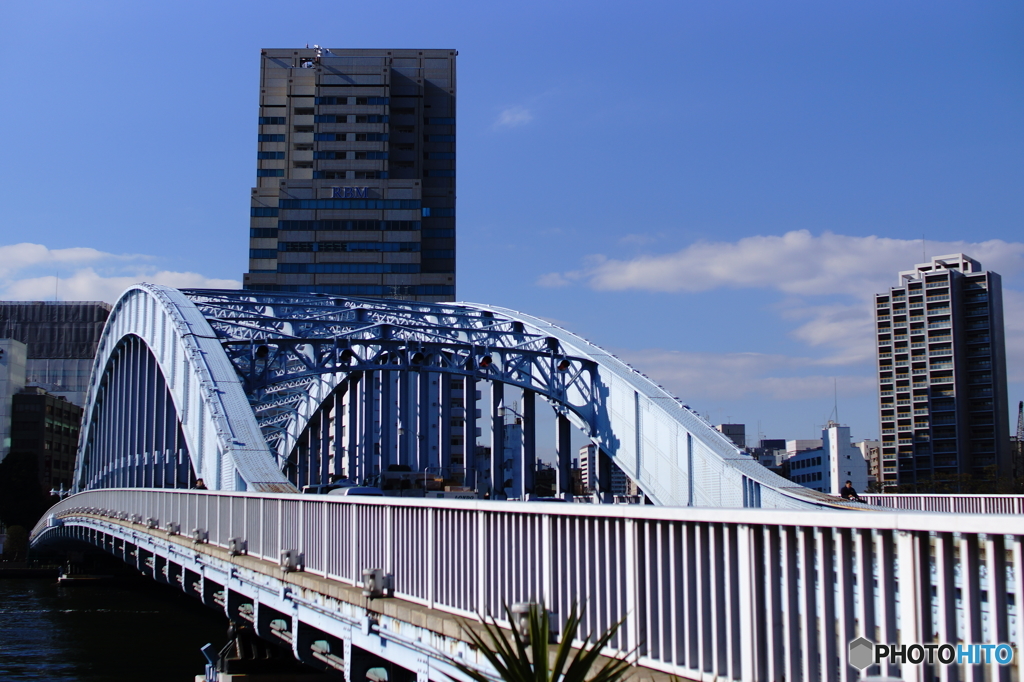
<box><xmin>244</xmin><ymin>47</ymin><xmax>457</xmax><ymax>301</ymax></box>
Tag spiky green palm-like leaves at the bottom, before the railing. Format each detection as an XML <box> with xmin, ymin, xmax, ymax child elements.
<box><xmin>449</xmin><ymin>604</ymin><xmax>631</xmax><ymax>682</ymax></box>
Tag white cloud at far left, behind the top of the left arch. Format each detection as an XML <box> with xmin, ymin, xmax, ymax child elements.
<box><xmin>0</xmin><ymin>244</ymin><xmax>241</xmax><ymax>302</ymax></box>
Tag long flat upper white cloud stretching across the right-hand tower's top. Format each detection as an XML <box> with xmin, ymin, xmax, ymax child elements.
<box><xmin>544</xmin><ymin>229</ymin><xmax>1024</xmax><ymax>297</ymax></box>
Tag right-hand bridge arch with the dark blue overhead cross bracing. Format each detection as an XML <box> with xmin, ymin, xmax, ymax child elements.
<box><xmin>176</xmin><ymin>290</ymin><xmax>827</xmax><ymax>507</ymax></box>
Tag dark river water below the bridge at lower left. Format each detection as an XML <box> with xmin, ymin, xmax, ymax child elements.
<box><xmin>0</xmin><ymin>579</ymin><xmax>227</xmax><ymax>682</ymax></box>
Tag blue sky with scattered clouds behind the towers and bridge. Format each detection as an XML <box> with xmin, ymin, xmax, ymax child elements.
<box><xmin>0</xmin><ymin>0</ymin><xmax>1024</xmax><ymax>438</ymax></box>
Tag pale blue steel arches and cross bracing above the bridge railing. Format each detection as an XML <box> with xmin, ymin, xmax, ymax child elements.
<box><xmin>76</xmin><ymin>285</ymin><xmax>842</xmax><ymax>508</ymax></box>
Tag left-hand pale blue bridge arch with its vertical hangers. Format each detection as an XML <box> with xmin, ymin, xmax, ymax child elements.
<box><xmin>75</xmin><ymin>284</ymin><xmax>294</xmax><ymax>492</ymax></box>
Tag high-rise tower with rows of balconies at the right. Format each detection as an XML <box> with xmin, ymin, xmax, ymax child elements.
<box><xmin>876</xmin><ymin>254</ymin><xmax>1010</xmax><ymax>485</ymax></box>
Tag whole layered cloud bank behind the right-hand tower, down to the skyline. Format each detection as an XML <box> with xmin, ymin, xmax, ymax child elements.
<box><xmin>537</xmin><ymin>230</ymin><xmax>1024</xmax><ymax>400</ymax></box>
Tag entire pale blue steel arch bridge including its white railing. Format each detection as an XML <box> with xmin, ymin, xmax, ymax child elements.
<box><xmin>33</xmin><ymin>285</ymin><xmax>1024</xmax><ymax>682</ymax></box>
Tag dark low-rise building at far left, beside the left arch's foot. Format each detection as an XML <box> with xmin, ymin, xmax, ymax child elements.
<box><xmin>10</xmin><ymin>387</ymin><xmax>82</xmax><ymax>491</ymax></box>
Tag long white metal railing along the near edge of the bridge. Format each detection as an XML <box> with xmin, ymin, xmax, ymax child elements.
<box><xmin>33</xmin><ymin>489</ymin><xmax>1024</xmax><ymax>682</ymax></box>
